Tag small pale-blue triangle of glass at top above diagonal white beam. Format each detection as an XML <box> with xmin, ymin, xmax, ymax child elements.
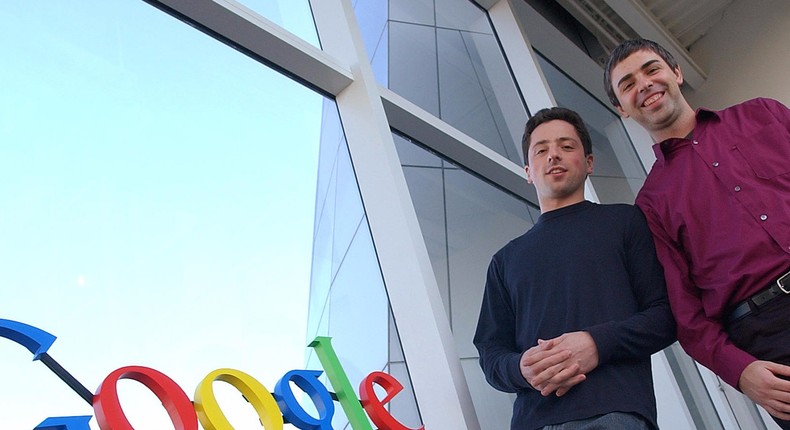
<box><xmin>237</xmin><ymin>0</ymin><xmax>320</xmax><ymax>47</ymax></box>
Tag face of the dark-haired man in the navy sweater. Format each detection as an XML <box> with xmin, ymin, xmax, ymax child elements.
<box><xmin>525</xmin><ymin>120</ymin><xmax>593</xmax><ymax>212</ymax></box>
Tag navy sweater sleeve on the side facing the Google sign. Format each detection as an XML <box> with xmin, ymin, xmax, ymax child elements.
<box><xmin>474</xmin><ymin>256</ymin><xmax>531</xmax><ymax>393</ymax></box>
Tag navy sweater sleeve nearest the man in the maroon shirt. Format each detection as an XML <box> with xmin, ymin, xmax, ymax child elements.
<box><xmin>586</xmin><ymin>208</ymin><xmax>676</xmax><ymax>364</ymax></box>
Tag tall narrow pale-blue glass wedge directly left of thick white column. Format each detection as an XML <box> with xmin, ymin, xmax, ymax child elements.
<box><xmin>307</xmin><ymin>101</ymin><xmax>420</xmax><ymax>429</ymax></box>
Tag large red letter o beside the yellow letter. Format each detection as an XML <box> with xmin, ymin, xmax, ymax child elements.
<box><xmin>93</xmin><ymin>366</ymin><xmax>198</xmax><ymax>430</ymax></box>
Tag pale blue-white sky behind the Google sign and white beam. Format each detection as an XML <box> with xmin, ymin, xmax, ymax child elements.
<box><xmin>0</xmin><ymin>0</ymin><xmax>323</xmax><ymax>429</ymax></box>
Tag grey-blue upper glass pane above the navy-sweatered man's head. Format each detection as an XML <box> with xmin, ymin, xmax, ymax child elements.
<box><xmin>355</xmin><ymin>0</ymin><xmax>527</xmax><ymax>165</ymax></box>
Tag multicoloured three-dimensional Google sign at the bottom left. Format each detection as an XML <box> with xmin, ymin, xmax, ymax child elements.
<box><xmin>0</xmin><ymin>319</ymin><xmax>424</xmax><ymax>430</ymax></box>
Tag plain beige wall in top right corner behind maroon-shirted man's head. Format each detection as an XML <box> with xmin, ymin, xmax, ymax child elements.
<box><xmin>686</xmin><ymin>0</ymin><xmax>790</xmax><ymax>109</ymax></box>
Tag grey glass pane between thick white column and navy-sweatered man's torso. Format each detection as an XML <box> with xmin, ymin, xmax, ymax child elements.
<box><xmin>393</xmin><ymin>134</ymin><xmax>539</xmax><ymax>430</ymax></box>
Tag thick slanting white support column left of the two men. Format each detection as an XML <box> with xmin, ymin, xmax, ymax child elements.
<box><xmin>311</xmin><ymin>0</ymin><xmax>480</xmax><ymax>430</ymax></box>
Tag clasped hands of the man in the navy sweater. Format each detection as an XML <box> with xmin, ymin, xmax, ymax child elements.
<box><xmin>519</xmin><ymin>331</ymin><xmax>598</xmax><ymax>397</ymax></box>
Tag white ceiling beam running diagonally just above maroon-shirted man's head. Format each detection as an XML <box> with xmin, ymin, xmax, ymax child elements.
<box><xmin>604</xmin><ymin>0</ymin><xmax>708</xmax><ymax>89</ymax></box>
